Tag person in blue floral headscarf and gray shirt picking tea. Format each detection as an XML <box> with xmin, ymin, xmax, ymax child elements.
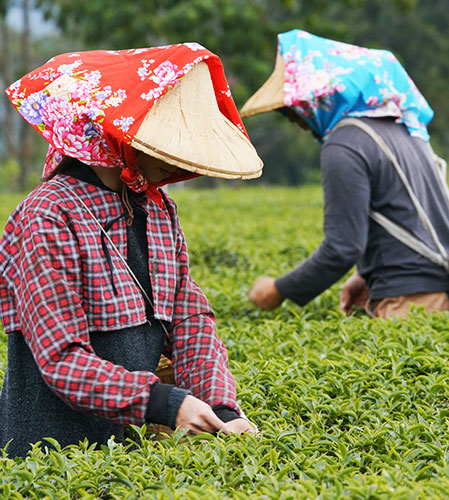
<box><xmin>241</xmin><ymin>30</ymin><xmax>449</xmax><ymax>317</ymax></box>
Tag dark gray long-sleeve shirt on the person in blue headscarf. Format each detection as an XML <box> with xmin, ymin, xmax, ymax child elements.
<box><xmin>276</xmin><ymin>118</ymin><xmax>449</xmax><ymax>305</ymax></box>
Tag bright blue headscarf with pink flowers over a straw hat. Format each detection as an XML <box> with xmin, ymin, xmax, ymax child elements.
<box><xmin>278</xmin><ymin>30</ymin><xmax>433</xmax><ymax>141</ymax></box>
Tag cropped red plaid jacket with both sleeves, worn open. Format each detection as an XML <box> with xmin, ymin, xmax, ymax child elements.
<box><xmin>0</xmin><ymin>175</ymin><xmax>239</xmax><ymax>424</ymax></box>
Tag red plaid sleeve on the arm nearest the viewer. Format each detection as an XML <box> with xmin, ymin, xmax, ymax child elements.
<box><xmin>11</xmin><ymin>214</ymin><xmax>158</xmax><ymax>424</ymax></box>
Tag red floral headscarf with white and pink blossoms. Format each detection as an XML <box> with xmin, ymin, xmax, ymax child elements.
<box><xmin>6</xmin><ymin>43</ymin><xmax>247</xmax><ymax>192</ymax></box>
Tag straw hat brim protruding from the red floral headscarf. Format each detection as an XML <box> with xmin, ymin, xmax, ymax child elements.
<box><xmin>131</xmin><ymin>62</ymin><xmax>263</xmax><ymax>179</ymax></box>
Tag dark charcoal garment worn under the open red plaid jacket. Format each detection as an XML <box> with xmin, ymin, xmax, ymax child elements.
<box><xmin>0</xmin><ymin>166</ymin><xmax>164</xmax><ymax>457</ymax></box>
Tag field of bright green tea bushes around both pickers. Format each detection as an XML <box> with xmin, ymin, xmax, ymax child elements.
<box><xmin>0</xmin><ymin>186</ymin><xmax>449</xmax><ymax>500</ymax></box>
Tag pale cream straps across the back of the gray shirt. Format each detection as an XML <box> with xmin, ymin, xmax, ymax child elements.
<box><xmin>332</xmin><ymin>118</ymin><xmax>449</xmax><ymax>272</ymax></box>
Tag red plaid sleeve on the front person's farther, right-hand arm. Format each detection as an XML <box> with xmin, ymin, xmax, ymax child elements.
<box><xmin>166</xmin><ymin>209</ymin><xmax>240</xmax><ymax>412</ymax></box>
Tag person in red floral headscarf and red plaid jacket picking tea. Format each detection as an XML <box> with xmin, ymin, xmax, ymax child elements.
<box><xmin>0</xmin><ymin>44</ymin><xmax>262</xmax><ymax>456</ymax></box>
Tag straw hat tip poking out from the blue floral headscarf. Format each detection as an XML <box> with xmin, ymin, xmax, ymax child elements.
<box><xmin>240</xmin><ymin>55</ymin><xmax>285</xmax><ymax>116</ymax></box>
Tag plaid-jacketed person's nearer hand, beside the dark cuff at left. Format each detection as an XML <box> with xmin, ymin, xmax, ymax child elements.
<box><xmin>176</xmin><ymin>395</ymin><xmax>229</xmax><ymax>434</ymax></box>
